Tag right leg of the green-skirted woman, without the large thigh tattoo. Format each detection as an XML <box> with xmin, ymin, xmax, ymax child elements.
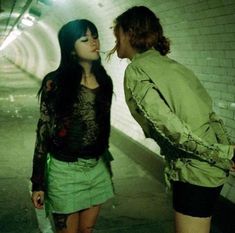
<box><xmin>78</xmin><ymin>205</ymin><xmax>101</xmax><ymax>233</ymax></box>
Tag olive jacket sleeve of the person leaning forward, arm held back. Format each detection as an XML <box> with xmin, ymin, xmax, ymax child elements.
<box><xmin>124</xmin><ymin>66</ymin><xmax>233</xmax><ymax>170</ymax></box>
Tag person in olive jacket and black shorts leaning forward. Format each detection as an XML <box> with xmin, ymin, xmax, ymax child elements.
<box><xmin>110</xmin><ymin>6</ymin><xmax>235</xmax><ymax>233</ymax></box>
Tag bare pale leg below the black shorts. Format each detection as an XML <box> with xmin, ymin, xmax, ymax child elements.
<box><xmin>175</xmin><ymin>211</ymin><xmax>211</xmax><ymax>233</ymax></box>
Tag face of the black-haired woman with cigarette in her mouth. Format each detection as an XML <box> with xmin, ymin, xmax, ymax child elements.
<box><xmin>73</xmin><ymin>28</ymin><xmax>100</xmax><ymax>62</ymax></box>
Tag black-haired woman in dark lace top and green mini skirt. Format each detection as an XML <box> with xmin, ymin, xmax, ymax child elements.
<box><xmin>31</xmin><ymin>19</ymin><xmax>113</xmax><ymax>233</ymax></box>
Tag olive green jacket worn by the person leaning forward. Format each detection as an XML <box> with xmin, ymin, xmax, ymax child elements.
<box><xmin>124</xmin><ymin>49</ymin><xmax>233</xmax><ymax>187</ymax></box>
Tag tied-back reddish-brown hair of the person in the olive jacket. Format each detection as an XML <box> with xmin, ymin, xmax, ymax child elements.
<box><xmin>108</xmin><ymin>6</ymin><xmax>170</xmax><ymax>56</ymax></box>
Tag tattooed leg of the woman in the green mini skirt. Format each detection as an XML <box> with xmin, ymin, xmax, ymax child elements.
<box><xmin>53</xmin><ymin>213</ymin><xmax>79</xmax><ymax>233</ymax></box>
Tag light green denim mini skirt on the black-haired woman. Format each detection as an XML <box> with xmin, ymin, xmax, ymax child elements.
<box><xmin>45</xmin><ymin>156</ymin><xmax>114</xmax><ymax>214</ymax></box>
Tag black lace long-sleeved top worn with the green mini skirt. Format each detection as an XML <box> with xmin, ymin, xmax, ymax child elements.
<box><xmin>31</xmin><ymin>77</ymin><xmax>111</xmax><ymax>191</ymax></box>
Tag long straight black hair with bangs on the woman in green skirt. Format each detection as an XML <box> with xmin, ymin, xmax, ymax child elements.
<box><xmin>38</xmin><ymin>19</ymin><xmax>112</xmax><ymax>115</ymax></box>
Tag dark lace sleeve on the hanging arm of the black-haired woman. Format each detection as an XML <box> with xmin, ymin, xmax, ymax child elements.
<box><xmin>31</xmin><ymin>83</ymin><xmax>51</xmax><ymax>191</ymax></box>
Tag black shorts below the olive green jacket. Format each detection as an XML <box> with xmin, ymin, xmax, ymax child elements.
<box><xmin>172</xmin><ymin>181</ymin><xmax>223</xmax><ymax>217</ymax></box>
